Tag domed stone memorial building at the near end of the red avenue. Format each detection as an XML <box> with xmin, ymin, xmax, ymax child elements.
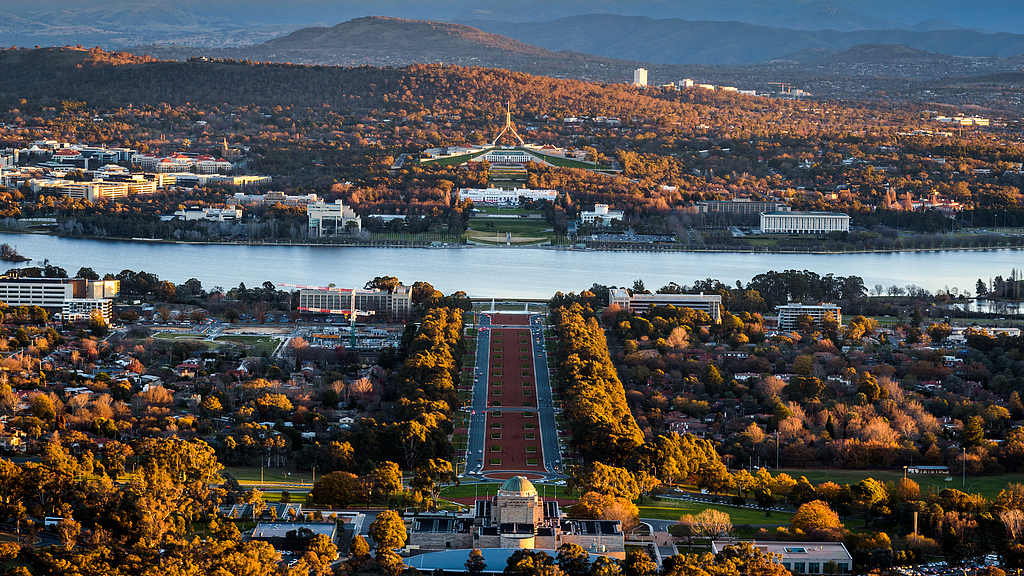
<box><xmin>409</xmin><ymin>477</ymin><xmax>626</xmax><ymax>559</ymax></box>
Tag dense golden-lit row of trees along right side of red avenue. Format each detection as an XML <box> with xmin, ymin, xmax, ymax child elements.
<box><xmin>551</xmin><ymin>303</ymin><xmax>643</xmax><ymax>463</ymax></box>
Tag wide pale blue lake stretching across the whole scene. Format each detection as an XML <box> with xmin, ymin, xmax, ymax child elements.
<box><xmin>0</xmin><ymin>233</ymin><xmax>1024</xmax><ymax>298</ymax></box>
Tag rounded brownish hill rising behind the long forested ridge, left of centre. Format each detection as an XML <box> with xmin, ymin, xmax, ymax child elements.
<box><xmin>125</xmin><ymin>16</ymin><xmax>649</xmax><ymax>80</ymax></box>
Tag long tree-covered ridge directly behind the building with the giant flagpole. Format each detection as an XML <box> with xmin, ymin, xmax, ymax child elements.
<box><xmin>0</xmin><ymin>48</ymin><xmax>736</xmax><ymax>122</ymax></box>
